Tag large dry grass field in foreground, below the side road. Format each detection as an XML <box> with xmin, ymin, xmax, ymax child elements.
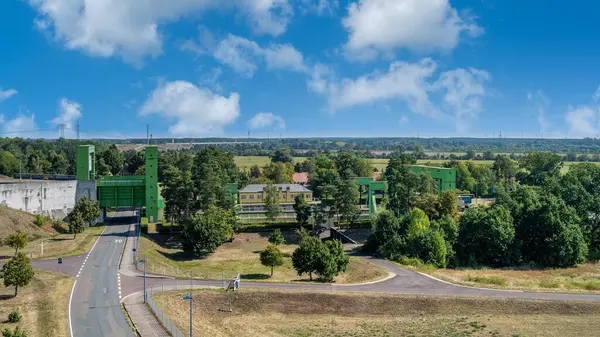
<box><xmin>153</xmin><ymin>288</ymin><xmax>600</xmax><ymax>337</ymax></box>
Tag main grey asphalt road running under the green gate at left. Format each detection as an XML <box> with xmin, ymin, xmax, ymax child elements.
<box><xmin>69</xmin><ymin>211</ymin><xmax>135</xmax><ymax>337</ymax></box>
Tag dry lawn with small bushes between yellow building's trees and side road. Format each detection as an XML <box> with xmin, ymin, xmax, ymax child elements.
<box><xmin>140</xmin><ymin>232</ymin><xmax>388</xmax><ymax>283</ymax></box>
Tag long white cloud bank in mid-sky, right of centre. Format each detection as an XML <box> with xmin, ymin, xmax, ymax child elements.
<box><xmin>308</xmin><ymin>58</ymin><xmax>491</xmax><ymax>131</ymax></box>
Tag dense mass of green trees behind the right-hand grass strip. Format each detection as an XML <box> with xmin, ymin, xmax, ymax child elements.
<box><xmin>365</xmin><ymin>152</ymin><xmax>600</xmax><ymax>267</ymax></box>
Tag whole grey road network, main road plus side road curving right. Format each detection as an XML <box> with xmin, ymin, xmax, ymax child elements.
<box><xmin>32</xmin><ymin>211</ymin><xmax>600</xmax><ymax>337</ymax></box>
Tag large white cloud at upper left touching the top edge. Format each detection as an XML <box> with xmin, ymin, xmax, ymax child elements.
<box><xmin>29</xmin><ymin>0</ymin><xmax>293</xmax><ymax>64</ymax></box>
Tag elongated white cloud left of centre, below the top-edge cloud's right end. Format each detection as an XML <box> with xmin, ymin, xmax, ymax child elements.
<box><xmin>188</xmin><ymin>31</ymin><xmax>308</xmax><ymax>77</ymax></box>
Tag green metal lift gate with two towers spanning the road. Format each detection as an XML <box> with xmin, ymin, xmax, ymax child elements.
<box><xmin>76</xmin><ymin>145</ymin><xmax>162</xmax><ymax>222</ymax></box>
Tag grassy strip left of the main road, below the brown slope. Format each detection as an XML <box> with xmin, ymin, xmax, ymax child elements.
<box><xmin>0</xmin><ymin>226</ymin><xmax>105</xmax><ymax>259</ymax></box>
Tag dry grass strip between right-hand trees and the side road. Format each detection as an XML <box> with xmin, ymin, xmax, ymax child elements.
<box><xmin>407</xmin><ymin>263</ymin><xmax>600</xmax><ymax>292</ymax></box>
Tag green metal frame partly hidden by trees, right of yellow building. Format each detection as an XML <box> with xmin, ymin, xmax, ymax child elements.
<box><xmin>354</xmin><ymin>165</ymin><xmax>456</xmax><ymax>217</ymax></box>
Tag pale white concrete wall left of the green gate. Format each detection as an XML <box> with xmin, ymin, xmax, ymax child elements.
<box><xmin>0</xmin><ymin>180</ymin><xmax>96</xmax><ymax>219</ymax></box>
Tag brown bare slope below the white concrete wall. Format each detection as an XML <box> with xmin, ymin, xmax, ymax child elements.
<box><xmin>0</xmin><ymin>205</ymin><xmax>56</xmax><ymax>245</ymax></box>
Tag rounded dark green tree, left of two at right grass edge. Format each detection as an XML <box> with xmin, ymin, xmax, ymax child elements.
<box><xmin>458</xmin><ymin>206</ymin><xmax>516</xmax><ymax>267</ymax></box>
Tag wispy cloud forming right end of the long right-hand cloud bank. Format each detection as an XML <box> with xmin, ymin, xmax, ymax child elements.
<box><xmin>433</xmin><ymin>68</ymin><xmax>491</xmax><ymax>132</ymax></box>
